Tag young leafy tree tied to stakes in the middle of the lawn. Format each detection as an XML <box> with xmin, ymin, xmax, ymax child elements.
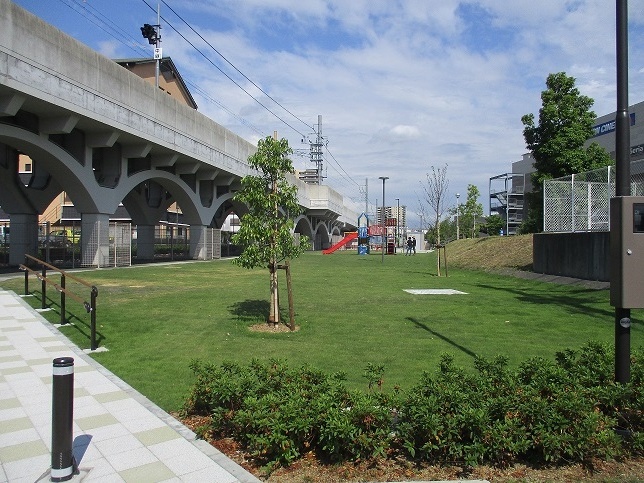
<box><xmin>233</xmin><ymin>136</ymin><xmax>308</xmax><ymax>329</ymax></box>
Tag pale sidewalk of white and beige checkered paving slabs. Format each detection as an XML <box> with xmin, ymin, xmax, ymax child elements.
<box><xmin>0</xmin><ymin>289</ymin><xmax>260</xmax><ymax>483</ymax></box>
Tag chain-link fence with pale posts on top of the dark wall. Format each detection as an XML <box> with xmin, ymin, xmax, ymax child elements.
<box><xmin>543</xmin><ymin>160</ymin><xmax>644</xmax><ymax>232</ymax></box>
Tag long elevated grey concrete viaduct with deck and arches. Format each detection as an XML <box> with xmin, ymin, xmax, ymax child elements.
<box><xmin>0</xmin><ymin>0</ymin><xmax>358</xmax><ymax>265</ymax></box>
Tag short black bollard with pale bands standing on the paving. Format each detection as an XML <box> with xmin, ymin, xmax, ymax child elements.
<box><xmin>51</xmin><ymin>357</ymin><xmax>76</xmax><ymax>481</ymax></box>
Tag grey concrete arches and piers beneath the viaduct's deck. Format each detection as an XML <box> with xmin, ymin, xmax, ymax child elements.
<box><xmin>0</xmin><ymin>124</ymin><xmax>330</xmax><ymax>265</ymax></box>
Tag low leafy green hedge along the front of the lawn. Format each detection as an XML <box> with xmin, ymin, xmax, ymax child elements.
<box><xmin>184</xmin><ymin>343</ymin><xmax>644</xmax><ymax>471</ymax></box>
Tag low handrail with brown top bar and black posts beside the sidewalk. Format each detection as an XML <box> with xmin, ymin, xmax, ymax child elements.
<box><xmin>20</xmin><ymin>255</ymin><xmax>98</xmax><ymax>351</ymax></box>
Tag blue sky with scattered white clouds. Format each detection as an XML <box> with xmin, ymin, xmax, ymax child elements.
<box><xmin>14</xmin><ymin>0</ymin><xmax>644</xmax><ymax>228</ymax></box>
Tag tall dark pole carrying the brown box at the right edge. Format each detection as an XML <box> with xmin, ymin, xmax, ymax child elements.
<box><xmin>611</xmin><ymin>0</ymin><xmax>631</xmax><ymax>384</ymax></box>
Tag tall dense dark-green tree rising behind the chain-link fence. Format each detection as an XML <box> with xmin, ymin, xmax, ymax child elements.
<box><xmin>521</xmin><ymin>72</ymin><xmax>613</xmax><ymax>233</ymax></box>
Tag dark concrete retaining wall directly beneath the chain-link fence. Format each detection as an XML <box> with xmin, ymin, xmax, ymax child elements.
<box><xmin>532</xmin><ymin>232</ymin><xmax>610</xmax><ymax>282</ymax></box>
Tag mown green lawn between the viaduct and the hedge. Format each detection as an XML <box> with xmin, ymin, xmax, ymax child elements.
<box><xmin>0</xmin><ymin>252</ymin><xmax>642</xmax><ymax>411</ymax></box>
